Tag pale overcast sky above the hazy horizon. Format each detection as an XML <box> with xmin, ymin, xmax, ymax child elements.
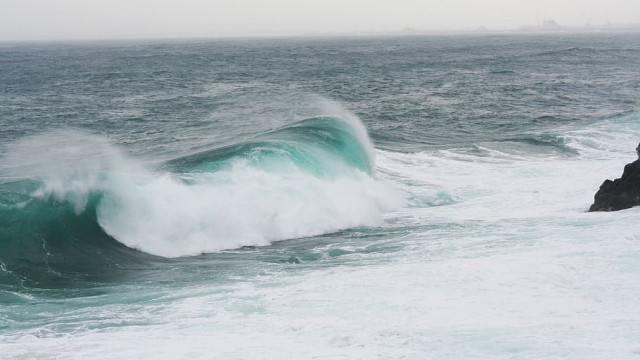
<box><xmin>0</xmin><ymin>0</ymin><xmax>640</xmax><ymax>41</ymax></box>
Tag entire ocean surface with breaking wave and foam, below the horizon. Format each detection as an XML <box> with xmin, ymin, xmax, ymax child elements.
<box><xmin>0</xmin><ymin>34</ymin><xmax>640</xmax><ymax>359</ymax></box>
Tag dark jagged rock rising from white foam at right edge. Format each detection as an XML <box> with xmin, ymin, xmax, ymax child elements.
<box><xmin>589</xmin><ymin>160</ymin><xmax>640</xmax><ymax>211</ymax></box>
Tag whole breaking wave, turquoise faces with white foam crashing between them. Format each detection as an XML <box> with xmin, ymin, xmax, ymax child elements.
<box><xmin>0</xmin><ymin>117</ymin><xmax>384</xmax><ymax>292</ymax></box>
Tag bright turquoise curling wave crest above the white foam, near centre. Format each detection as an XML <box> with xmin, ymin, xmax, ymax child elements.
<box><xmin>165</xmin><ymin>117</ymin><xmax>373</xmax><ymax>177</ymax></box>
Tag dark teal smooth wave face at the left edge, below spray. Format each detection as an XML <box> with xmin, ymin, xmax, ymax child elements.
<box><xmin>0</xmin><ymin>180</ymin><xmax>152</xmax><ymax>292</ymax></box>
